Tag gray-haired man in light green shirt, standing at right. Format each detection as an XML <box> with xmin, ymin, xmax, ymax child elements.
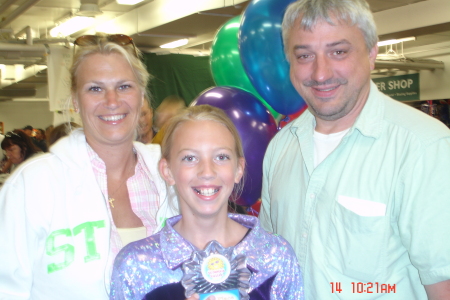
<box><xmin>260</xmin><ymin>0</ymin><xmax>450</xmax><ymax>300</ymax></box>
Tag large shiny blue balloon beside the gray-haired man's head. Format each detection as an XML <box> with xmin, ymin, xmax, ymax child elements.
<box><xmin>239</xmin><ymin>0</ymin><xmax>306</xmax><ymax>115</ymax></box>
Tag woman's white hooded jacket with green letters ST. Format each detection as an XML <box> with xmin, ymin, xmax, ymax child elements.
<box><xmin>0</xmin><ymin>130</ymin><xmax>177</xmax><ymax>300</ymax></box>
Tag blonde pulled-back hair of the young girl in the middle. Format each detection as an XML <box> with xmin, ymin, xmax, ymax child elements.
<box><xmin>161</xmin><ymin>105</ymin><xmax>245</xmax><ymax>202</ymax></box>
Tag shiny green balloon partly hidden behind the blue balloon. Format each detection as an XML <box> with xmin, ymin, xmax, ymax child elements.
<box><xmin>210</xmin><ymin>16</ymin><xmax>279</xmax><ymax>119</ymax></box>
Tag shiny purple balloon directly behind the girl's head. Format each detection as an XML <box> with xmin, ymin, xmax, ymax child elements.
<box><xmin>191</xmin><ymin>86</ymin><xmax>277</xmax><ymax>206</ymax></box>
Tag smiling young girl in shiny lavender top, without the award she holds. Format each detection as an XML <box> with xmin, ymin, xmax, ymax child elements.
<box><xmin>111</xmin><ymin>105</ymin><xmax>303</xmax><ymax>300</ymax></box>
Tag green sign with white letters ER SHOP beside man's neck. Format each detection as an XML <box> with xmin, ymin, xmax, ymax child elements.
<box><xmin>372</xmin><ymin>73</ymin><xmax>420</xmax><ymax>101</ymax></box>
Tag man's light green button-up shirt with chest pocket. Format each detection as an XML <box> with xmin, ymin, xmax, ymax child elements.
<box><xmin>260</xmin><ymin>83</ymin><xmax>450</xmax><ymax>300</ymax></box>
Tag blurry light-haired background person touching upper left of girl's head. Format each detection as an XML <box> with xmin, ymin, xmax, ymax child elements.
<box><xmin>152</xmin><ymin>95</ymin><xmax>186</xmax><ymax>144</ymax></box>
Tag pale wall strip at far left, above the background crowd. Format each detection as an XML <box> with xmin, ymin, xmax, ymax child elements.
<box><xmin>0</xmin><ymin>101</ymin><xmax>53</xmax><ymax>132</ymax></box>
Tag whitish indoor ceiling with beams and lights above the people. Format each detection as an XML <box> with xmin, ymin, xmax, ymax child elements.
<box><xmin>0</xmin><ymin>0</ymin><xmax>450</xmax><ymax>100</ymax></box>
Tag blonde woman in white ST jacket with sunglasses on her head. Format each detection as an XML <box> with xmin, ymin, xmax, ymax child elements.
<box><xmin>0</xmin><ymin>34</ymin><xmax>177</xmax><ymax>300</ymax></box>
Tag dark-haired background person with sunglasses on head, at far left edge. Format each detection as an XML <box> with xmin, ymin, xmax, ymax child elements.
<box><xmin>0</xmin><ymin>129</ymin><xmax>41</xmax><ymax>173</ymax></box>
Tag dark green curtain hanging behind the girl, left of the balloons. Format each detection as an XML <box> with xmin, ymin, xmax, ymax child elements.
<box><xmin>143</xmin><ymin>53</ymin><xmax>215</xmax><ymax>108</ymax></box>
